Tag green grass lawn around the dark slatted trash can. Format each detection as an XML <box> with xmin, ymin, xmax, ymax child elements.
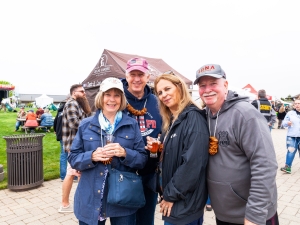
<box><xmin>0</xmin><ymin>108</ymin><xmax>60</xmax><ymax>190</ymax></box>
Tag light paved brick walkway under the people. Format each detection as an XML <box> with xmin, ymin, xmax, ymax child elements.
<box><xmin>0</xmin><ymin>129</ymin><xmax>300</xmax><ymax>225</ymax></box>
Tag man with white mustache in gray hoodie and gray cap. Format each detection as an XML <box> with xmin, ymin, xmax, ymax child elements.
<box><xmin>194</xmin><ymin>64</ymin><xmax>279</xmax><ymax>225</ymax></box>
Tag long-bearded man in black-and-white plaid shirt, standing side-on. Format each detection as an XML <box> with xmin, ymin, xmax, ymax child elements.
<box><xmin>58</xmin><ymin>84</ymin><xmax>91</xmax><ymax>213</ymax></box>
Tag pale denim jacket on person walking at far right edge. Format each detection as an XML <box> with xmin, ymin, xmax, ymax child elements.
<box><xmin>282</xmin><ymin>110</ymin><xmax>300</xmax><ymax>137</ymax></box>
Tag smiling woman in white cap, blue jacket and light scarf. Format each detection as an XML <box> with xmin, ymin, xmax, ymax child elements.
<box><xmin>68</xmin><ymin>77</ymin><xmax>148</xmax><ymax>225</ymax></box>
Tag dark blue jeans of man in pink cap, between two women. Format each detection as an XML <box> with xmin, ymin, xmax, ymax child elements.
<box><xmin>136</xmin><ymin>185</ymin><xmax>158</xmax><ymax>225</ymax></box>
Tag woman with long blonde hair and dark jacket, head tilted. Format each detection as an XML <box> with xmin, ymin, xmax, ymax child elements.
<box><xmin>147</xmin><ymin>74</ymin><xmax>209</xmax><ymax>225</ymax></box>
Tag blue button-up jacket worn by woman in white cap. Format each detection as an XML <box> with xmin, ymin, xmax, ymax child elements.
<box><xmin>68</xmin><ymin>110</ymin><xmax>148</xmax><ymax>225</ymax></box>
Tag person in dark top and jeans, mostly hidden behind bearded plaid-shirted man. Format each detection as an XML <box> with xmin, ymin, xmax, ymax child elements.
<box><xmin>53</xmin><ymin>101</ymin><xmax>68</xmax><ymax>181</ymax></box>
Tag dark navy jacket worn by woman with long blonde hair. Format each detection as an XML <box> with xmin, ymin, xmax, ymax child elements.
<box><xmin>161</xmin><ymin>105</ymin><xmax>209</xmax><ymax>224</ymax></box>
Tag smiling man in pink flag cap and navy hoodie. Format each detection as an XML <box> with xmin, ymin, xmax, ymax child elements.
<box><xmin>122</xmin><ymin>58</ymin><xmax>162</xmax><ymax>225</ymax></box>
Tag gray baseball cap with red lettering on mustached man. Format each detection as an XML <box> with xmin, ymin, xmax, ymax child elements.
<box><xmin>194</xmin><ymin>64</ymin><xmax>226</xmax><ymax>84</ymax></box>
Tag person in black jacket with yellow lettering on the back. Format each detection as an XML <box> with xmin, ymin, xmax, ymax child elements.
<box><xmin>251</xmin><ymin>89</ymin><xmax>276</xmax><ymax>131</ymax></box>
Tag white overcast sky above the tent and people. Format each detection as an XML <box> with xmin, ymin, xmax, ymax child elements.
<box><xmin>0</xmin><ymin>0</ymin><xmax>300</xmax><ymax>98</ymax></box>
